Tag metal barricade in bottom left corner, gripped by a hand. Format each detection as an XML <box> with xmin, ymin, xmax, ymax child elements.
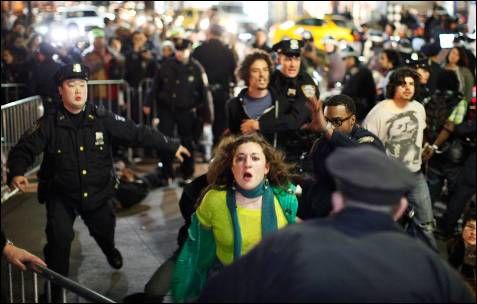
<box><xmin>7</xmin><ymin>264</ymin><xmax>116</xmax><ymax>303</ymax></box>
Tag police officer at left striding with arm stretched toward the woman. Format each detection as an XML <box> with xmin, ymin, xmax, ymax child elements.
<box><xmin>7</xmin><ymin>64</ymin><xmax>190</xmax><ymax>297</ymax></box>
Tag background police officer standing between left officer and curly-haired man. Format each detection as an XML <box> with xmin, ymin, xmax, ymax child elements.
<box><xmin>145</xmin><ymin>39</ymin><xmax>211</xmax><ymax>180</ymax></box>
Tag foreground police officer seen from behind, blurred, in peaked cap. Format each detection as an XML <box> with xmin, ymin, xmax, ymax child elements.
<box><xmin>199</xmin><ymin>146</ymin><xmax>475</xmax><ymax>303</ymax></box>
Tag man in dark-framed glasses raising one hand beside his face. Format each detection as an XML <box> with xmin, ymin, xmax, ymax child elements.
<box><xmin>298</xmin><ymin>94</ymin><xmax>384</xmax><ymax>219</ymax></box>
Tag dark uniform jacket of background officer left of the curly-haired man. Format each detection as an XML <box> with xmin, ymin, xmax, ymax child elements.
<box><xmin>149</xmin><ymin>58</ymin><xmax>210</xmax><ymax>121</ymax></box>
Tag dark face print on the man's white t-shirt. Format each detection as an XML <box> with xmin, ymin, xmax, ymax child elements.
<box><xmin>384</xmin><ymin>111</ymin><xmax>421</xmax><ymax>167</ymax></box>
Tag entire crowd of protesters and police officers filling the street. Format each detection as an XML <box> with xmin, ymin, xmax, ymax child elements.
<box><xmin>2</xmin><ymin>1</ymin><xmax>476</xmax><ymax>302</ymax></box>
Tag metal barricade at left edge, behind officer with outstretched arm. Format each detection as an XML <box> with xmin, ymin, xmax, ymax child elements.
<box><xmin>1</xmin><ymin>96</ymin><xmax>43</xmax><ymax>198</ymax></box>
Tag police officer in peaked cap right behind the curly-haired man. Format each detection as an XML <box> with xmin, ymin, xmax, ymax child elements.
<box><xmin>270</xmin><ymin>39</ymin><xmax>320</xmax><ymax>169</ymax></box>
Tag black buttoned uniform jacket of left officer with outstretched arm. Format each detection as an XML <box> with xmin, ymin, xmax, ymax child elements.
<box><xmin>7</xmin><ymin>102</ymin><xmax>179</xmax><ymax>210</ymax></box>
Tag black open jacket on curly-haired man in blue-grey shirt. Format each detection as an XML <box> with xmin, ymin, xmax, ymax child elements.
<box><xmin>227</xmin><ymin>88</ymin><xmax>303</xmax><ymax>148</ymax></box>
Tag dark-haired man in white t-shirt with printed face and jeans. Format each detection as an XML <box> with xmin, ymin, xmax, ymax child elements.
<box><xmin>363</xmin><ymin>68</ymin><xmax>437</xmax><ymax>249</ymax></box>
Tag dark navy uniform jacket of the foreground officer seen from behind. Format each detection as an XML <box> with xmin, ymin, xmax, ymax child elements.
<box><xmin>199</xmin><ymin>208</ymin><xmax>475</xmax><ymax>303</ymax></box>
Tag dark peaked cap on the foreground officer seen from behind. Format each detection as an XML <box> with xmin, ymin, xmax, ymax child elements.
<box><xmin>326</xmin><ymin>145</ymin><xmax>415</xmax><ymax>205</ymax></box>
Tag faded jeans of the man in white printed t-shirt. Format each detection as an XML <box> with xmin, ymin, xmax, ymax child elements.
<box><xmin>407</xmin><ymin>172</ymin><xmax>437</xmax><ymax>250</ymax></box>
